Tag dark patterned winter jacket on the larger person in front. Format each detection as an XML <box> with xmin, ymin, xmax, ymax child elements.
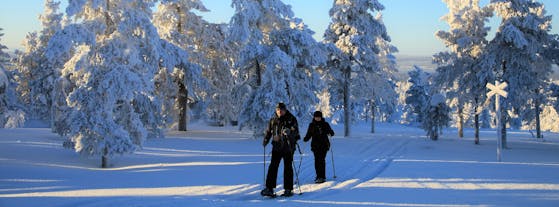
<box><xmin>264</xmin><ymin>111</ymin><xmax>301</xmax><ymax>153</ymax></box>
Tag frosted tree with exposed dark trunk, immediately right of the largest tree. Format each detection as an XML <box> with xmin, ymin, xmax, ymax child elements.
<box><xmin>154</xmin><ymin>0</ymin><xmax>224</xmax><ymax>131</ymax></box>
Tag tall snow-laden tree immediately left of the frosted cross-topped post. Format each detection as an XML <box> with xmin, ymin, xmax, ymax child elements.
<box><xmin>433</xmin><ymin>0</ymin><xmax>493</xmax><ymax>144</ymax></box>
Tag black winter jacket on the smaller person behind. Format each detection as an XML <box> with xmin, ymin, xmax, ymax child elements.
<box><xmin>304</xmin><ymin>119</ymin><xmax>334</xmax><ymax>151</ymax></box>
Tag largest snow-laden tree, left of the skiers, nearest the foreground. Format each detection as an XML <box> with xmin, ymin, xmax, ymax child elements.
<box><xmin>47</xmin><ymin>0</ymin><xmax>187</xmax><ymax>167</ymax></box>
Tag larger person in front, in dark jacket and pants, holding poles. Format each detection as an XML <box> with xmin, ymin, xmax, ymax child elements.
<box><xmin>260</xmin><ymin>103</ymin><xmax>301</xmax><ymax>196</ymax></box>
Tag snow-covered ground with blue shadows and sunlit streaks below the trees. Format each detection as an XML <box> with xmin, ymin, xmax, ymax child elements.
<box><xmin>0</xmin><ymin>124</ymin><xmax>559</xmax><ymax>207</ymax></box>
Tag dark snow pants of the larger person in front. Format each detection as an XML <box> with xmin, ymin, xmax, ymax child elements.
<box><xmin>266</xmin><ymin>151</ymin><xmax>293</xmax><ymax>190</ymax></box>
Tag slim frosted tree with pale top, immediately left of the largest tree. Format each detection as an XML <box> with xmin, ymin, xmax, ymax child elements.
<box><xmin>14</xmin><ymin>0</ymin><xmax>63</xmax><ymax>124</ymax></box>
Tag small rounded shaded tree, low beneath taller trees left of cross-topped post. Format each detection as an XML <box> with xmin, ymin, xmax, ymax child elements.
<box><xmin>421</xmin><ymin>94</ymin><xmax>450</xmax><ymax>141</ymax></box>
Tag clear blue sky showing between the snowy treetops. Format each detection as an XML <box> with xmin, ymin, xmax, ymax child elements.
<box><xmin>0</xmin><ymin>0</ymin><xmax>559</xmax><ymax>56</ymax></box>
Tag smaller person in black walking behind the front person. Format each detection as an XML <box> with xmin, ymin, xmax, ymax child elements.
<box><xmin>304</xmin><ymin>111</ymin><xmax>334</xmax><ymax>183</ymax></box>
